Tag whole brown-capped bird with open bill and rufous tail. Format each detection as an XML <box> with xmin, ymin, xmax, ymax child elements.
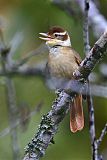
<box><xmin>39</xmin><ymin>26</ymin><xmax>84</xmax><ymax>133</ymax></box>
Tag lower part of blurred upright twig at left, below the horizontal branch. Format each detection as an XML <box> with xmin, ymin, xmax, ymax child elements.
<box><xmin>5</xmin><ymin>76</ymin><xmax>20</xmax><ymax>160</ymax></box>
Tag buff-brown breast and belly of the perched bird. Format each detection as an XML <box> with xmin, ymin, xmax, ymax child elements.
<box><xmin>48</xmin><ymin>53</ymin><xmax>78</xmax><ymax>79</ymax></box>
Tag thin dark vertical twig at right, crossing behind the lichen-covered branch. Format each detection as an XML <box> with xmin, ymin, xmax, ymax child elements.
<box><xmin>83</xmin><ymin>0</ymin><xmax>98</xmax><ymax>160</ymax></box>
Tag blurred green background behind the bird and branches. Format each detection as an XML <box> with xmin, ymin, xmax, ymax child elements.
<box><xmin>0</xmin><ymin>0</ymin><xmax>107</xmax><ymax>160</ymax></box>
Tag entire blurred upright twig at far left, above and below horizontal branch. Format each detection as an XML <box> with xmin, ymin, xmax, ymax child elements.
<box><xmin>0</xmin><ymin>31</ymin><xmax>20</xmax><ymax>160</ymax></box>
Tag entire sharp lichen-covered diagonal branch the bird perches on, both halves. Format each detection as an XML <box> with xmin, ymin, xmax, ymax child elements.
<box><xmin>24</xmin><ymin>32</ymin><xmax>107</xmax><ymax>160</ymax></box>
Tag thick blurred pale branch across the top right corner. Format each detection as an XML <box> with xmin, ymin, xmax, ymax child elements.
<box><xmin>52</xmin><ymin>0</ymin><xmax>107</xmax><ymax>38</ymax></box>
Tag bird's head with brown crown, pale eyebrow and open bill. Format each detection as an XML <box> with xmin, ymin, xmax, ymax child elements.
<box><xmin>39</xmin><ymin>27</ymin><xmax>71</xmax><ymax>48</ymax></box>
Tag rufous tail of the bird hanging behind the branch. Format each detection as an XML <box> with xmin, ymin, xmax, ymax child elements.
<box><xmin>70</xmin><ymin>95</ymin><xmax>84</xmax><ymax>133</ymax></box>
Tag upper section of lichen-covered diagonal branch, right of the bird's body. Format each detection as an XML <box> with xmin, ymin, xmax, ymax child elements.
<box><xmin>74</xmin><ymin>31</ymin><xmax>107</xmax><ymax>79</ymax></box>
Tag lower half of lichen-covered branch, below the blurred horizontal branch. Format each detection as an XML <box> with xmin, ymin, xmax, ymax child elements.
<box><xmin>24</xmin><ymin>91</ymin><xmax>70</xmax><ymax>160</ymax></box>
